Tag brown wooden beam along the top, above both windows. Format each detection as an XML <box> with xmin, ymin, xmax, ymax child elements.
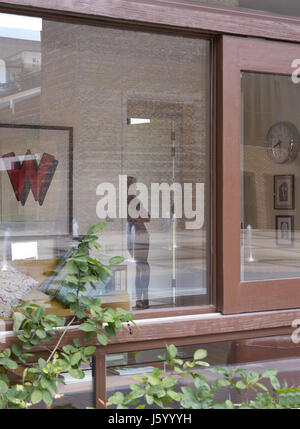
<box><xmin>0</xmin><ymin>0</ymin><xmax>300</xmax><ymax>41</ymax></box>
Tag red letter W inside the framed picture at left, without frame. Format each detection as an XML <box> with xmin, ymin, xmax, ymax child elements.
<box><xmin>2</xmin><ymin>149</ymin><xmax>58</xmax><ymax>206</ymax></box>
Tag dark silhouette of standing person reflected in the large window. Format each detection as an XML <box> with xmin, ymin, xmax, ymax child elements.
<box><xmin>127</xmin><ymin>176</ymin><xmax>150</xmax><ymax>310</ymax></box>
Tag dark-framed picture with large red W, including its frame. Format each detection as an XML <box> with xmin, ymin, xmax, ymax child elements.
<box><xmin>0</xmin><ymin>124</ymin><xmax>73</xmax><ymax>238</ymax></box>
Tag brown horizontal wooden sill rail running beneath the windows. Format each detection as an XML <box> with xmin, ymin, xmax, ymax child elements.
<box><xmin>0</xmin><ymin>310</ymin><xmax>300</xmax><ymax>352</ymax></box>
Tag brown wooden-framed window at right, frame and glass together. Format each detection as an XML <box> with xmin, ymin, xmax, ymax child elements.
<box><xmin>219</xmin><ymin>36</ymin><xmax>300</xmax><ymax>314</ymax></box>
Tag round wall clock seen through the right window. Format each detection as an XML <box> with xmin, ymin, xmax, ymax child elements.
<box><xmin>267</xmin><ymin>122</ymin><xmax>300</xmax><ymax>164</ymax></box>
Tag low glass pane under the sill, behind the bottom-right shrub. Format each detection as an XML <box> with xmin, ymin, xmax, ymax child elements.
<box><xmin>106</xmin><ymin>335</ymin><xmax>300</xmax><ymax>408</ymax></box>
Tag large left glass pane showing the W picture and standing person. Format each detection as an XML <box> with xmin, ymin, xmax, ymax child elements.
<box><xmin>0</xmin><ymin>14</ymin><xmax>211</xmax><ymax>318</ymax></box>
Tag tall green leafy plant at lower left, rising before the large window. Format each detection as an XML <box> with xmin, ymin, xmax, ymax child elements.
<box><xmin>0</xmin><ymin>222</ymin><xmax>133</xmax><ymax>408</ymax></box>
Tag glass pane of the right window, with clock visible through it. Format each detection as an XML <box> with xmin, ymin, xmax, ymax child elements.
<box><xmin>241</xmin><ymin>72</ymin><xmax>300</xmax><ymax>281</ymax></box>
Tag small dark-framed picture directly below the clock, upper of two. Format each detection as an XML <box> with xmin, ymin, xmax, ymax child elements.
<box><xmin>274</xmin><ymin>174</ymin><xmax>295</xmax><ymax>210</ymax></box>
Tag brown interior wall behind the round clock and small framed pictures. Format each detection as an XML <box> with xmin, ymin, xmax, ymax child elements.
<box><xmin>242</xmin><ymin>73</ymin><xmax>300</xmax><ymax>229</ymax></box>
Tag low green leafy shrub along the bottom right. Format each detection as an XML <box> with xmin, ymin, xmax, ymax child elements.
<box><xmin>109</xmin><ymin>345</ymin><xmax>300</xmax><ymax>409</ymax></box>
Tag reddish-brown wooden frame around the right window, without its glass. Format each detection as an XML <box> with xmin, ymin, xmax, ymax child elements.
<box><xmin>221</xmin><ymin>36</ymin><xmax>300</xmax><ymax>314</ymax></box>
